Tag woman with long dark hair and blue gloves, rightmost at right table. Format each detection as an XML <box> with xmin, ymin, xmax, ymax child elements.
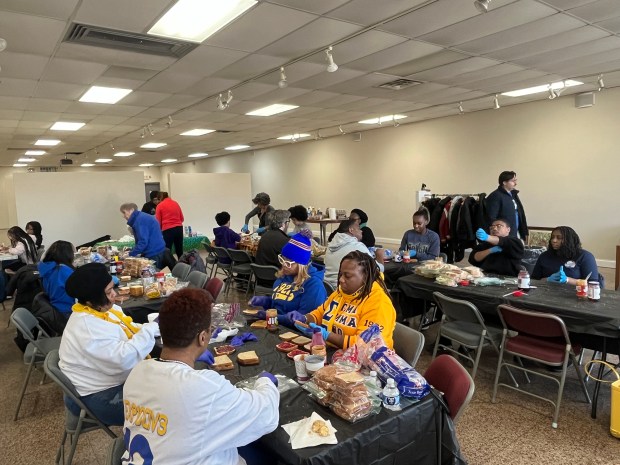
<box><xmin>531</xmin><ymin>226</ymin><xmax>604</xmax><ymax>287</ymax></box>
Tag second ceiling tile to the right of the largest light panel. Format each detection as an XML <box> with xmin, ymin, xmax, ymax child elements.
<box><xmin>260</xmin><ymin>18</ymin><xmax>361</xmax><ymax>58</ymax></box>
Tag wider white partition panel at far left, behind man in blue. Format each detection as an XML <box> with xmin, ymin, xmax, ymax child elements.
<box><xmin>13</xmin><ymin>171</ymin><xmax>144</xmax><ymax>246</ymax></box>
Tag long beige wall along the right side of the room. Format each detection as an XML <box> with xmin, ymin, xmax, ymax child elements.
<box><xmin>161</xmin><ymin>85</ymin><xmax>620</xmax><ymax>264</ymax></box>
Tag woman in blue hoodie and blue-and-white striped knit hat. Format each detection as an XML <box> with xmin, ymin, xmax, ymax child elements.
<box><xmin>249</xmin><ymin>230</ymin><xmax>327</xmax><ymax>325</ymax></box>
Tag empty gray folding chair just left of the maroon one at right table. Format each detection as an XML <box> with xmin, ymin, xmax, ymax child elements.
<box><xmin>433</xmin><ymin>292</ymin><xmax>517</xmax><ymax>386</ymax></box>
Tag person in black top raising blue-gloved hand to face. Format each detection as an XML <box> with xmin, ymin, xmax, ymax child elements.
<box><xmin>469</xmin><ymin>219</ymin><xmax>524</xmax><ymax>276</ymax></box>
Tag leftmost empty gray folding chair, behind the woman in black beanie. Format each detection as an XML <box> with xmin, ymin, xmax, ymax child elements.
<box><xmin>11</xmin><ymin>307</ymin><xmax>60</xmax><ymax>421</ymax></box>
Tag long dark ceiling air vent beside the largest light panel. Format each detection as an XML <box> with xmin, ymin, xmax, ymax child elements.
<box><xmin>64</xmin><ymin>23</ymin><xmax>198</xmax><ymax>58</ymax></box>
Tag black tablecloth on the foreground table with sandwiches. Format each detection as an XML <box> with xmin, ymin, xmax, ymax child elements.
<box><xmin>208</xmin><ymin>322</ymin><xmax>463</xmax><ymax>465</ymax></box>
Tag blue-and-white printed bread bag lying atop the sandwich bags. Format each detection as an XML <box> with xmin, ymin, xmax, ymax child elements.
<box><xmin>356</xmin><ymin>325</ymin><xmax>430</xmax><ymax>399</ymax></box>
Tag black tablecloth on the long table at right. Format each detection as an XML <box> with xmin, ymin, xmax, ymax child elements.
<box><xmin>395</xmin><ymin>275</ymin><xmax>620</xmax><ymax>338</ymax></box>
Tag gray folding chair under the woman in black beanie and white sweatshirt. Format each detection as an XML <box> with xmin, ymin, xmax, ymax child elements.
<box><xmin>43</xmin><ymin>350</ymin><xmax>116</xmax><ymax>465</ymax></box>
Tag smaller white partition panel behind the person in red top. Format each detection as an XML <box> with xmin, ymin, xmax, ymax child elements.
<box><xmin>168</xmin><ymin>173</ymin><xmax>254</xmax><ymax>239</ymax></box>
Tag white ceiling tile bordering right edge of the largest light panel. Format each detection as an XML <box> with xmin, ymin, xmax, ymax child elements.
<box><xmin>206</xmin><ymin>3</ymin><xmax>317</xmax><ymax>52</ymax></box>
